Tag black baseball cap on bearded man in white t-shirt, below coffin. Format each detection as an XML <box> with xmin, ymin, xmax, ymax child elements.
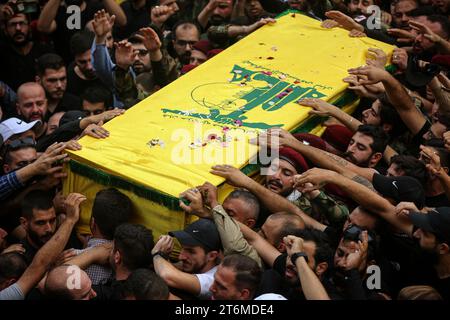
<box><xmin>169</xmin><ymin>219</ymin><xmax>222</xmax><ymax>251</ymax></box>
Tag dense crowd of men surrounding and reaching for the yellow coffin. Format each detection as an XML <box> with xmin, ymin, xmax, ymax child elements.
<box><xmin>0</xmin><ymin>0</ymin><xmax>450</xmax><ymax>300</ymax></box>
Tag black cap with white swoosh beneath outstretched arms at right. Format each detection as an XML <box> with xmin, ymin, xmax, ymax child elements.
<box><xmin>372</xmin><ymin>173</ymin><xmax>425</xmax><ymax>209</ymax></box>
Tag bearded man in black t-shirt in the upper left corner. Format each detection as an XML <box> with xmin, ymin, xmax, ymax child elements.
<box><xmin>0</xmin><ymin>12</ymin><xmax>52</xmax><ymax>91</ymax></box>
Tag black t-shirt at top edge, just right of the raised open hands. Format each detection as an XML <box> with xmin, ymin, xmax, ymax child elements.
<box><xmin>114</xmin><ymin>0</ymin><xmax>156</xmax><ymax>41</ymax></box>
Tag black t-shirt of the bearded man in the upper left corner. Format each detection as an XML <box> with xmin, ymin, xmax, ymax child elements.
<box><xmin>0</xmin><ymin>43</ymin><xmax>53</xmax><ymax>91</ymax></box>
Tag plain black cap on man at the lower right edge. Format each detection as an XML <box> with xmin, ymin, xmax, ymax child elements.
<box><xmin>409</xmin><ymin>207</ymin><xmax>450</xmax><ymax>244</ymax></box>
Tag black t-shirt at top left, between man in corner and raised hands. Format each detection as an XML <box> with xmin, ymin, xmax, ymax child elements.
<box><xmin>52</xmin><ymin>1</ymin><xmax>104</xmax><ymax>64</ymax></box>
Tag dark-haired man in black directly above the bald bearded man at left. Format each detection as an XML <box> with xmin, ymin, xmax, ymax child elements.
<box><xmin>36</xmin><ymin>53</ymin><xmax>81</xmax><ymax>118</ymax></box>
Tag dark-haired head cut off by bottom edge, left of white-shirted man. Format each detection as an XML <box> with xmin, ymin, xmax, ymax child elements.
<box><xmin>123</xmin><ymin>268</ymin><xmax>169</xmax><ymax>300</ymax></box>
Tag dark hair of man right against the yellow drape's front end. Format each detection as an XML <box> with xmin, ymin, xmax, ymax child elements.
<box><xmin>92</xmin><ymin>188</ymin><xmax>133</xmax><ymax>240</ymax></box>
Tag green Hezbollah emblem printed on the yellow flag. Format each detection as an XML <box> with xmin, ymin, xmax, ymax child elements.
<box><xmin>162</xmin><ymin>65</ymin><xmax>325</xmax><ymax>130</ymax></box>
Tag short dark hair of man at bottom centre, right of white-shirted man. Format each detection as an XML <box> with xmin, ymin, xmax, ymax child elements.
<box><xmin>221</xmin><ymin>254</ymin><xmax>262</xmax><ymax>299</ymax></box>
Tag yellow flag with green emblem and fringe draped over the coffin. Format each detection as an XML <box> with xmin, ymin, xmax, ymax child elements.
<box><xmin>64</xmin><ymin>14</ymin><xmax>392</xmax><ymax>236</ymax></box>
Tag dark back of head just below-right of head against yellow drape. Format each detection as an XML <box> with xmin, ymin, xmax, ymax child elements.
<box><xmin>114</xmin><ymin>223</ymin><xmax>154</xmax><ymax>271</ymax></box>
